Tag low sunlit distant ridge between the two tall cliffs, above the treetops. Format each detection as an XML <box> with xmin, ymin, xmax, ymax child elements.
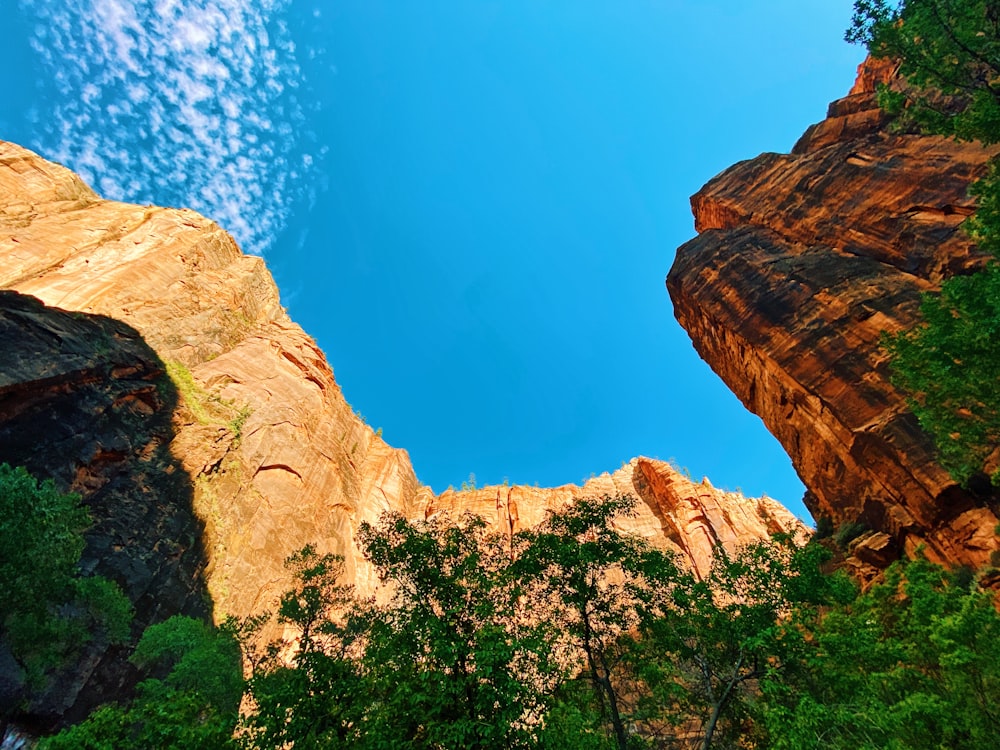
<box><xmin>425</xmin><ymin>458</ymin><xmax>807</xmax><ymax>575</ymax></box>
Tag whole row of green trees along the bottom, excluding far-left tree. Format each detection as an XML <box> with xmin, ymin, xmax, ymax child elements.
<box><xmin>42</xmin><ymin>497</ymin><xmax>1000</xmax><ymax>750</ymax></box>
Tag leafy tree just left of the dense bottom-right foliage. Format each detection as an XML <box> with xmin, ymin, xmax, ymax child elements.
<box><xmin>632</xmin><ymin>538</ymin><xmax>853</xmax><ymax>750</ymax></box>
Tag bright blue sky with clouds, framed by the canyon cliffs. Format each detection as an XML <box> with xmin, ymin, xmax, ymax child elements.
<box><xmin>0</xmin><ymin>0</ymin><xmax>862</xmax><ymax>514</ymax></box>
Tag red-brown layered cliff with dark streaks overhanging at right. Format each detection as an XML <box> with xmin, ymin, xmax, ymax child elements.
<box><xmin>667</xmin><ymin>62</ymin><xmax>997</xmax><ymax>566</ymax></box>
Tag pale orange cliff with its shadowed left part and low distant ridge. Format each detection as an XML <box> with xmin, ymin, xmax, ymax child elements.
<box><xmin>0</xmin><ymin>142</ymin><xmax>802</xmax><ymax>727</ymax></box>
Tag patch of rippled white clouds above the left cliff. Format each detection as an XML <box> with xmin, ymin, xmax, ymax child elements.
<box><xmin>21</xmin><ymin>0</ymin><xmax>320</xmax><ymax>253</ymax></box>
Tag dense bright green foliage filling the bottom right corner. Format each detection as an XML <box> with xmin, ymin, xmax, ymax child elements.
<box><xmin>759</xmin><ymin>559</ymin><xmax>1000</xmax><ymax>750</ymax></box>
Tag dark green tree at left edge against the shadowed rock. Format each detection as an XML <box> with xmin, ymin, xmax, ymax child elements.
<box><xmin>0</xmin><ymin>464</ymin><xmax>132</xmax><ymax>687</ymax></box>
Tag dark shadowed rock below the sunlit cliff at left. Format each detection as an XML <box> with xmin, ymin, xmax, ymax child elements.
<box><xmin>0</xmin><ymin>291</ymin><xmax>211</xmax><ymax>727</ymax></box>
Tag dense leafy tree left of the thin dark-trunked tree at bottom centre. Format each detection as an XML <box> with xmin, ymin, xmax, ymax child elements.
<box><xmin>359</xmin><ymin>514</ymin><xmax>558</xmax><ymax>750</ymax></box>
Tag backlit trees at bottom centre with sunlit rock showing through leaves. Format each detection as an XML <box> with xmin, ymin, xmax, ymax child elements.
<box><xmin>238</xmin><ymin>497</ymin><xmax>853</xmax><ymax>750</ymax></box>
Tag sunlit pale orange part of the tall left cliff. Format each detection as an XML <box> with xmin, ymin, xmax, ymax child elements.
<box><xmin>0</xmin><ymin>142</ymin><xmax>431</xmax><ymax>618</ymax></box>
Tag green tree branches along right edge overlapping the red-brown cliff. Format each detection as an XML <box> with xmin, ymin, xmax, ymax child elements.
<box><xmin>847</xmin><ymin>0</ymin><xmax>1000</xmax><ymax>484</ymax></box>
